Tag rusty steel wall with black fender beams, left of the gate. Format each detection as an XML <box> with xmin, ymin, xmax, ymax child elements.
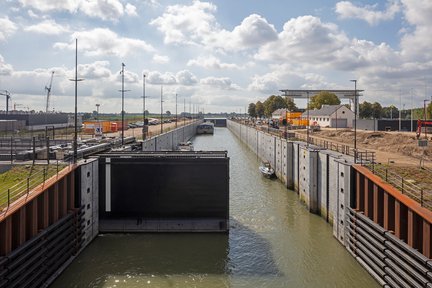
<box><xmin>0</xmin><ymin>165</ymin><xmax>83</xmax><ymax>288</ymax></box>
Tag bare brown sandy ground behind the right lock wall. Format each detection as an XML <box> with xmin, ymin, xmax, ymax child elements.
<box><xmin>299</xmin><ymin>128</ymin><xmax>432</xmax><ymax>168</ymax></box>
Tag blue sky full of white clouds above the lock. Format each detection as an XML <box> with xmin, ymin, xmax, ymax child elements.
<box><xmin>0</xmin><ymin>0</ymin><xmax>432</xmax><ymax>113</ymax></box>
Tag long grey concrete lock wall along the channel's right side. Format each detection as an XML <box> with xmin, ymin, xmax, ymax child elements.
<box><xmin>227</xmin><ymin>121</ymin><xmax>353</xmax><ymax>245</ymax></box>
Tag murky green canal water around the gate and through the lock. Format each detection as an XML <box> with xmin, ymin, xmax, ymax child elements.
<box><xmin>51</xmin><ymin>128</ymin><xmax>378</xmax><ymax>288</ymax></box>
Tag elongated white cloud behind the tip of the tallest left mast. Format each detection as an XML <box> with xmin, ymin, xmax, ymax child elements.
<box><xmin>54</xmin><ymin>28</ymin><xmax>154</xmax><ymax>57</ymax></box>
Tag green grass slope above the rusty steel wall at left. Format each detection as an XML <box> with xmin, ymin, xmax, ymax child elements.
<box><xmin>0</xmin><ymin>164</ymin><xmax>66</xmax><ymax>210</ymax></box>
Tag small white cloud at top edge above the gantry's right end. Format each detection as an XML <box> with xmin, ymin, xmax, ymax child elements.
<box><xmin>336</xmin><ymin>0</ymin><xmax>401</xmax><ymax>25</ymax></box>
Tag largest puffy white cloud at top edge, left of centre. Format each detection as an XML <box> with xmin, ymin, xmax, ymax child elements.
<box><xmin>150</xmin><ymin>1</ymin><xmax>277</xmax><ymax>51</ymax></box>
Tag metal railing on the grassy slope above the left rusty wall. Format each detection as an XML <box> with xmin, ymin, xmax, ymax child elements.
<box><xmin>0</xmin><ymin>162</ymin><xmax>70</xmax><ymax>212</ymax></box>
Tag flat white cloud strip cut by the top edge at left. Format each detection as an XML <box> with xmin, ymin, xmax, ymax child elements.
<box><xmin>19</xmin><ymin>0</ymin><xmax>137</xmax><ymax>21</ymax></box>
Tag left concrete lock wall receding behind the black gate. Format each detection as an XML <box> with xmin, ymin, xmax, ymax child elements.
<box><xmin>142</xmin><ymin>120</ymin><xmax>202</xmax><ymax>151</ymax></box>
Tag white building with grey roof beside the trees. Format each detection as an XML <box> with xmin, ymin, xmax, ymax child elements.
<box><xmin>302</xmin><ymin>105</ymin><xmax>354</xmax><ymax>128</ymax></box>
